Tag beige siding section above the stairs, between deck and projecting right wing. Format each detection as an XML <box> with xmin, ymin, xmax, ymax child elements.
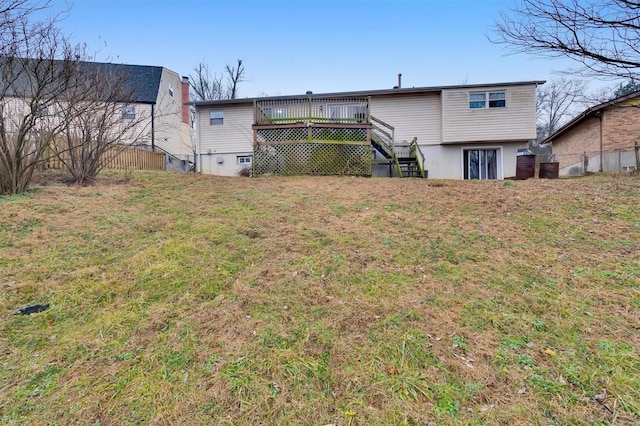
<box><xmin>370</xmin><ymin>93</ymin><xmax>441</xmax><ymax>145</ymax></box>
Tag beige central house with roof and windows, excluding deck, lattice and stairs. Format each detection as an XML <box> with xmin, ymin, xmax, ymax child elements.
<box><xmin>195</xmin><ymin>81</ymin><xmax>544</xmax><ymax>179</ymax></box>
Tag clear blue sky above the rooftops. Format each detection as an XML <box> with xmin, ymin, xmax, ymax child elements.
<box><xmin>53</xmin><ymin>0</ymin><xmax>592</xmax><ymax>97</ymax></box>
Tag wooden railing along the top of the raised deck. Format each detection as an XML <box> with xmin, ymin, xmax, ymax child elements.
<box><xmin>253</xmin><ymin>96</ymin><xmax>370</xmax><ymax>125</ymax></box>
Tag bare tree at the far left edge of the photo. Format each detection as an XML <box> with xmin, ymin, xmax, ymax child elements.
<box><xmin>0</xmin><ymin>0</ymin><xmax>80</xmax><ymax>194</ymax></box>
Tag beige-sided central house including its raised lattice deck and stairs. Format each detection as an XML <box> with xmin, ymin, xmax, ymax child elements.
<box><xmin>195</xmin><ymin>81</ymin><xmax>544</xmax><ymax>179</ymax></box>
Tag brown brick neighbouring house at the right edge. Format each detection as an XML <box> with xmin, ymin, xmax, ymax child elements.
<box><xmin>542</xmin><ymin>92</ymin><xmax>640</xmax><ymax>176</ymax></box>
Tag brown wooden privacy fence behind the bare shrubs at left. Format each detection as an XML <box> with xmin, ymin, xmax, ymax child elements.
<box><xmin>43</xmin><ymin>147</ymin><xmax>165</xmax><ymax>170</ymax></box>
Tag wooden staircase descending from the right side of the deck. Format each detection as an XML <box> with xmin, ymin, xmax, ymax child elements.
<box><xmin>370</xmin><ymin>116</ymin><xmax>426</xmax><ymax>178</ymax></box>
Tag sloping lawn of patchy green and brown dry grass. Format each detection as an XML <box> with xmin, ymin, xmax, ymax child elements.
<box><xmin>0</xmin><ymin>172</ymin><xmax>640</xmax><ymax>425</ymax></box>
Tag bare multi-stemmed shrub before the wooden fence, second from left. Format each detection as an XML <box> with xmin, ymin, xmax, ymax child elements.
<box><xmin>51</xmin><ymin>62</ymin><xmax>150</xmax><ymax>185</ymax></box>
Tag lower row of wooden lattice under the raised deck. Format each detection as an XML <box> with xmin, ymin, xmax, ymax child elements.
<box><xmin>253</xmin><ymin>142</ymin><xmax>371</xmax><ymax>176</ymax></box>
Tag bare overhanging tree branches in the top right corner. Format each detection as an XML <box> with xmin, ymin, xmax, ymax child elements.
<box><xmin>492</xmin><ymin>0</ymin><xmax>640</xmax><ymax>78</ymax></box>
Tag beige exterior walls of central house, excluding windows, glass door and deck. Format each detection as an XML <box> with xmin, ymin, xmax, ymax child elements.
<box><xmin>197</xmin><ymin>84</ymin><xmax>536</xmax><ymax>179</ymax></box>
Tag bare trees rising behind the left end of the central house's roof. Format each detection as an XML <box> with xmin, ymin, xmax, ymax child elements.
<box><xmin>189</xmin><ymin>59</ymin><xmax>245</xmax><ymax>101</ymax></box>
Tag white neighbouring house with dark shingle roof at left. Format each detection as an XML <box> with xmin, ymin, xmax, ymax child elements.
<box><xmin>0</xmin><ymin>58</ymin><xmax>195</xmax><ymax>170</ymax></box>
